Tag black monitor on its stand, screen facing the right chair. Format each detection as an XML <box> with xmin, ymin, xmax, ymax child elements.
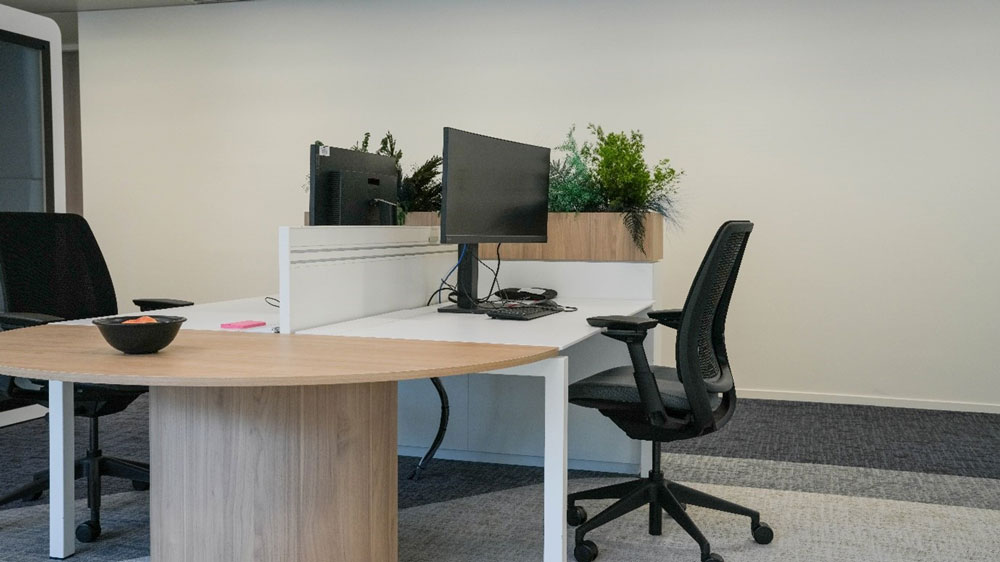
<box><xmin>438</xmin><ymin>127</ymin><xmax>550</xmax><ymax>312</ymax></box>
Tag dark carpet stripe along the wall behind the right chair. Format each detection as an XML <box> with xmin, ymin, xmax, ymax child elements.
<box><xmin>664</xmin><ymin>400</ymin><xmax>1000</xmax><ymax>479</ymax></box>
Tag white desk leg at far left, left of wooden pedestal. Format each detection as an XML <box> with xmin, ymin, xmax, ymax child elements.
<box><xmin>49</xmin><ymin>381</ymin><xmax>76</xmax><ymax>560</ymax></box>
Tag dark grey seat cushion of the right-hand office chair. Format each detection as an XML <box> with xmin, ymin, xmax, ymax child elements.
<box><xmin>569</xmin><ymin>366</ymin><xmax>722</xmax><ymax>412</ymax></box>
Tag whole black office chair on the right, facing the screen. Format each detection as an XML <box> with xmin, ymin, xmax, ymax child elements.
<box><xmin>567</xmin><ymin>221</ymin><xmax>774</xmax><ymax>562</ymax></box>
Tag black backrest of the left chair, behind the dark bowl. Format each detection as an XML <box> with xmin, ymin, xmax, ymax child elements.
<box><xmin>0</xmin><ymin>213</ymin><xmax>118</xmax><ymax>320</ymax></box>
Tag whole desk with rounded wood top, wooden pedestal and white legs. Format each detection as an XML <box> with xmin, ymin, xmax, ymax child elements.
<box><xmin>0</xmin><ymin>298</ymin><xmax>652</xmax><ymax>562</ymax></box>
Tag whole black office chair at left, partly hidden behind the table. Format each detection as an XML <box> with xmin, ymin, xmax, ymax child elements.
<box><xmin>0</xmin><ymin>213</ymin><xmax>193</xmax><ymax>542</ymax></box>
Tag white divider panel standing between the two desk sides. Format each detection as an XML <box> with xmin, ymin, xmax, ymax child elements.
<box><xmin>278</xmin><ymin>226</ymin><xmax>458</xmax><ymax>334</ymax></box>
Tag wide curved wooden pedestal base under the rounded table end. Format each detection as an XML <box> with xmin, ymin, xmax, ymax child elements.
<box><xmin>150</xmin><ymin>382</ymin><xmax>397</xmax><ymax>562</ymax></box>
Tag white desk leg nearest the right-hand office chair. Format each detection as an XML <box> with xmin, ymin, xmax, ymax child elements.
<box><xmin>540</xmin><ymin>357</ymin><xmax>569</xmax><ymax>562</ymax></box>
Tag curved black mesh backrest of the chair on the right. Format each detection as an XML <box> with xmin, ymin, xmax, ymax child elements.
<box><xmin>677</xmin><ymin>221</ymin><xmax>753</xmax><ymax>392</ymax></box>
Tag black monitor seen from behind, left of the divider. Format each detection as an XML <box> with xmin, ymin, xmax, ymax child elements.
<box><xmin>309</xmin><ymin>144</ymin><xmax>399</xmax><ymax>225</ymax></box>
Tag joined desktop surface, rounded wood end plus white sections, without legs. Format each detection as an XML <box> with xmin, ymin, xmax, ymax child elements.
<box><xmin>0</xmin><ymin>297</ymin><xmax>652</xmax><ymax>387</ymax></box>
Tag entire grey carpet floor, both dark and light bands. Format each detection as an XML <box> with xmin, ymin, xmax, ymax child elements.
<box><xmin>0</xmin><ymin>398</ymin><xmax>1000</xmax><ymax>562</ymax></box>
